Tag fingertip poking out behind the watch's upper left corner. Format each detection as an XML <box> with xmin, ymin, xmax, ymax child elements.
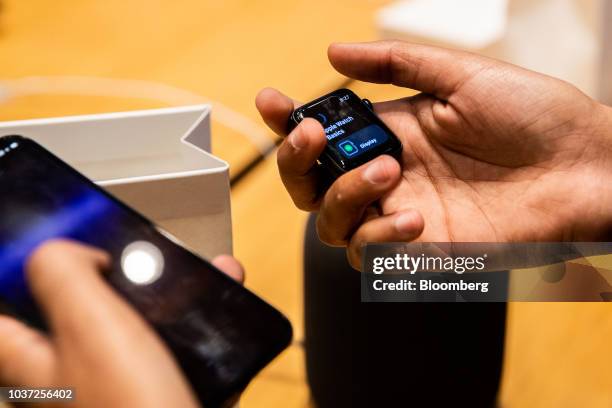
<box><xmin>255</xmin><ymin>88</ymin><xmax>300</xmax><ymax>136</ymax></box>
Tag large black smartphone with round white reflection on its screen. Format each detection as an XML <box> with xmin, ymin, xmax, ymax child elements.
<box><xmin>0</xmin><ymin>136</ymin><xmax>292</xmax><ymax>407</ymax></box>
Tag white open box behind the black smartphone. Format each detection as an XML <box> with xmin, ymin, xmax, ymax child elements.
<box><xmin>0</xmin><ymin>105</ymin><xmax>232</xmax><ymax>258</ymax></box>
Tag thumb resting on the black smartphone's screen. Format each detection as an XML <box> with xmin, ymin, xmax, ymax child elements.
<box><xmin>27</xmin><ymin>241</ymin><xmax>155</xmax><ymax>352</ymax></box>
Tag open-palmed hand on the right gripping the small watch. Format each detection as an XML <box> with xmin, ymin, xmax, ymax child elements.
<box><xmin>256</xmin><ymin>42</ymin><xmax>612</xmax><ymax>267</ymax></box>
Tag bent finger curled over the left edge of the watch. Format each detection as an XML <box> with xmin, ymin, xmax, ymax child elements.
<box><xmin>277</xmin><ymin>118</ymin><xmax>327</xmax><ymax>211</ymax></box>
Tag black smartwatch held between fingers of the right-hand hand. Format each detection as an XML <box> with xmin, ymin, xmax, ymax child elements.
<box><xmin>289</xmin><ymin>89</ymin><xmax>402</xmax><ymax>177</ymax></box>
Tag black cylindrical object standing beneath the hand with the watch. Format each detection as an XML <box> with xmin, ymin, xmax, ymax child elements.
<box><xmin>304</xmin><ymin>217</ymin><xmax>506</xmax><ymax>408</ymax></box>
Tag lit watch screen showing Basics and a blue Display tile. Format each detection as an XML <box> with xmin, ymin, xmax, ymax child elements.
<box><xmin>303</xmin><ymin>92</ymin><xmax>389</xmax><ymax>159</ymax></box>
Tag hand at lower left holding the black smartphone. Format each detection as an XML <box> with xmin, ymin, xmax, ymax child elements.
<box><xmin>0</xmin><ymin>241</ymin><xmax>243</xmax><ymax>408</ymax></box>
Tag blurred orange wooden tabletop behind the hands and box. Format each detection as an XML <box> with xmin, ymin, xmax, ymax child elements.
<box><xmin>0</xmin><ymin>0</ymin><xmax>612</xmax><ymax>408</ymax></box>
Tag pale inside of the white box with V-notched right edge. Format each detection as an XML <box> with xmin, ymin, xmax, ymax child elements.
<box><xmin>0</xmin><ymin>105</ymin><xmax>228</xmax><ymax>186</ymax></box>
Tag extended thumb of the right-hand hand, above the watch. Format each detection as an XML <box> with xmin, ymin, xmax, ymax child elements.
<box><xmin>328</xmin><ymin>41</ymin><xmax>497</xmax><ymax>99</ymax></box>
